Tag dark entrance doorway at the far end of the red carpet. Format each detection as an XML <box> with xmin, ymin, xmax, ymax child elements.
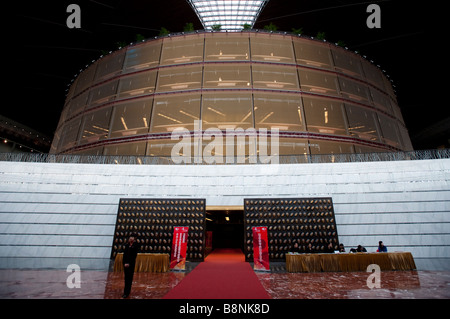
<box><xmin>206</xmin><ymin>210</ymin><xmax>244</xmax><ymax>251</ymax></box>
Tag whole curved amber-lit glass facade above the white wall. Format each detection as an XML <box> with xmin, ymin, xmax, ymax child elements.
<box><xmin>51</xmin><ymin>31</ymin><xmax>412</xmax><ymax>160</ymax></box>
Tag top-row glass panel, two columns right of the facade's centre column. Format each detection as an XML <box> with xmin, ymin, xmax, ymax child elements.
<box><xmin>294</xmin><ymin>39</ymin><xmax>332</xmax><ymax>69</ymax></box>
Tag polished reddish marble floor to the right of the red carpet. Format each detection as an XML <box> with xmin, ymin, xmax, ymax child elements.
<box><xmin>257</xmin><ymin>271</ymin><xmax>450</xmax><ymax>299</ymax></box>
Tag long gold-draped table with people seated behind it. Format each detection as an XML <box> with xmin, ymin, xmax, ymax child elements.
<box><xmin>286</xmin><ymin>252</ymin><xmax>416</xmax><ymax>272</ymax></box>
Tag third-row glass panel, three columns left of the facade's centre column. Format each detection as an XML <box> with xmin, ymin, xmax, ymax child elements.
<box><xmin>80</xmin><ymin>108</ymin><xmax>111</xmax><ymax>144</ymax></box>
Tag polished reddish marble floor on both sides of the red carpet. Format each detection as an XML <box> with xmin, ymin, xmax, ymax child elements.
<box><xmin>0</xmin><ymin>265</ymin><xmax>450</xmax><ymax>299</ymax></box>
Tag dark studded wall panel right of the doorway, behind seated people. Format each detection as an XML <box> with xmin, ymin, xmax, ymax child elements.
<box><xmin>244</xmin><ymin>197</ymin><xmax>339</xmax><ymax>261</ymax></box>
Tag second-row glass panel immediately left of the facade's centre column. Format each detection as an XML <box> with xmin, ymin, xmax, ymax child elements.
<box><xmin>157</xmin><ymin>66</ymin><xmax>202</xmax><ymax>92</ymax></box>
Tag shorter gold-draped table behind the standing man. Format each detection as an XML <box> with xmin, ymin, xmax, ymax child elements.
<box><xmin>114</xmin><ymin>253</ymin><xmax>169</xmax><ymax>272</ymax></box>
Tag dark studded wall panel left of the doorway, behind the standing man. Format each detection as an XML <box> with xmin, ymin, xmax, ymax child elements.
<box><xmin>111</xmin><ymin>198</ymin><xmax>206</xmax><ymax>261</ymax></box>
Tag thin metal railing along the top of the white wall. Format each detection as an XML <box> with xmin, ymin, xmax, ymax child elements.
<box><xmin>0</xmin><ymin>149</ymin><xmax>450</xmax><ymax>165</ymax></box>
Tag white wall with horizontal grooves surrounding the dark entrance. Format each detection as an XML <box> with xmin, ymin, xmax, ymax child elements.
<box><xmin>0</xmin><ymin>159</ymin><xmax>450</xmax><ymax>270</ymax></box>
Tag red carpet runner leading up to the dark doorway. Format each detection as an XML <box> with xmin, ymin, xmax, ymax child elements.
<box><xmin>164</xmin><ymin>249</ymin><xmax>270</xmax><ymax>299</ymax></box>
